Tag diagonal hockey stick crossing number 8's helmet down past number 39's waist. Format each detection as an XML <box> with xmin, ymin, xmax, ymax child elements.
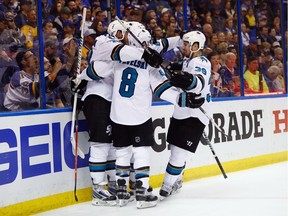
<box><xmin>115</xmin><ymin>16</ymin><xmax>228</xmax><ymax>138</ymax></box>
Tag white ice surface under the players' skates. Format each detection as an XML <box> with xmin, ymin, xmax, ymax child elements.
<box><xmin>37</xmin><ymin>162</ymin><xmax>288</xmax><ymax>216</ymax></box>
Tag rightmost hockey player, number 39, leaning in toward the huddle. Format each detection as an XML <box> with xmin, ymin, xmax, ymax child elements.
<box><xmin>159</xmin><ymin>31</ymin><xmax>211</xmax><ymax>200</ymax></box>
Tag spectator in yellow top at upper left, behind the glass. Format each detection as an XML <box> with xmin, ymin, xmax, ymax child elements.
<box><xmin>21</xmin><ymin>9</ymin><xmax>38</xmax><ymax>49</ymax></box>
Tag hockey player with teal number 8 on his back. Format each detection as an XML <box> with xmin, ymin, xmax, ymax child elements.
<box><xmin>110</xmin><ymin>29</ymin><xmax>204</xmax><ymax>208</ymax></box>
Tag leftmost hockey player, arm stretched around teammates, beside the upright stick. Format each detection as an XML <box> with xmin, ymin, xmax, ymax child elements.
<box><xmin>72</xmin><ymin>21</ymin><xmax>161</xmax><ymax>205</ymax></box>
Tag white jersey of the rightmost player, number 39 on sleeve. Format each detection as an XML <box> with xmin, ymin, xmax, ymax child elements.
<box><xmin>173</xmin><ymin>56</ymin><xmax>211</xmax><ymax>125</ymax></box>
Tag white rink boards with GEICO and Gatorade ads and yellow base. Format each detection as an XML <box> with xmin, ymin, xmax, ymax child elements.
<box><xmin>0</xmin><ymin>97</ymin><xmax>288</xmax><ymax>215</ymax></box>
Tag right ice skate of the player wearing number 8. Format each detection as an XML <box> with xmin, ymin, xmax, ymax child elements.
<box><xmin>136</xmin><ymin>181</ymin><xmax>158</xmax><ymax>209</ymax></box>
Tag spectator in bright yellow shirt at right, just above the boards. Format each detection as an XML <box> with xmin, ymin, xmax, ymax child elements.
<box><xmin>244</xmin><ymin>56</ymin><xmax>269</xmax><ymax>94</ymax></box>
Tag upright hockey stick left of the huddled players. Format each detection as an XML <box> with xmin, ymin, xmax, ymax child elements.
<box><xmin>70</xmin><ymin>8</ymin><xmax>87</xmax><ymax>202</ymax></box>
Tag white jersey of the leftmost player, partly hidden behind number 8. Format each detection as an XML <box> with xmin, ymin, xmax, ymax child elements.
<box><xmin>79</xmin><ymin>35</ymin><xmax>144</xmax><ymax>101</ymax></box>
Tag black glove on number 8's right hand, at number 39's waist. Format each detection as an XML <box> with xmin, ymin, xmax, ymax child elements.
<box><xmin>178</xmin><ymin>92</ymin><xmax>205</xmax><ymax>109</ymax></box>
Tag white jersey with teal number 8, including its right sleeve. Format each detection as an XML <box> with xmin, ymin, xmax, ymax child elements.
<box><xmin>110</xmin><ymin>60</ymin><xmax>180</xmax><ymax>125</ymax></box>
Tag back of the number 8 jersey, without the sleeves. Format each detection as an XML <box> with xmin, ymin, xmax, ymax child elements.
<box><xmin>110</xmin><ymin>60</ymin><xmax>152</xmax><ymax>125</ymax></box>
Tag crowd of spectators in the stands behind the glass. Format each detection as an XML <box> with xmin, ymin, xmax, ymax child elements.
<box><xmin>0</xmin><ymin>0</ymin><xmax>287</xmax><ymax>110</ymax></box>
